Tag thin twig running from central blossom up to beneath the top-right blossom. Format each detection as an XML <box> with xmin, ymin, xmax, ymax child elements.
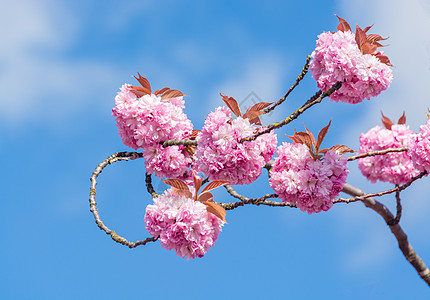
<box><xmin>240</xmin><ymin>81</ymin><xmax>342</xmax><ymax>143</ymax></box>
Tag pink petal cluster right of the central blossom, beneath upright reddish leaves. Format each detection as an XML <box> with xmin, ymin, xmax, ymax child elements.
<box><xmin>269</xmin><ymin>143</ymin><xmax>349</xmax><ymax>214</ymax></box>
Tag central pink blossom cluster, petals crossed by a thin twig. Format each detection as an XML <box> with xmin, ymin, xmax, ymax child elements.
<box><xmin>194</xmin><ymin>106</ymin><xmax>277</xmax><ymax>185</ymax></box>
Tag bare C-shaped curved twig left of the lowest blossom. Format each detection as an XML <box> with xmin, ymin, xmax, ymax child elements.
<box><xmin>90</xmin><ymin>152</ymin><xmax>158</xmax><ymax>248</ymax></box>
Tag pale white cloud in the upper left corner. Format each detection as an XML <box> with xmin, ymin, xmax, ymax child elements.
<box><xmin>0</xmin><ymin>1</ymin><xmax>113</xmax><ymax>128</ymax></box>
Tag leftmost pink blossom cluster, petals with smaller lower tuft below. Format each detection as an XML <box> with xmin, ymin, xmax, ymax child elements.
<box><xmin>112</xmin><ymin>84</ymin><xmax>193</xmax><ymax>178</ymax></box>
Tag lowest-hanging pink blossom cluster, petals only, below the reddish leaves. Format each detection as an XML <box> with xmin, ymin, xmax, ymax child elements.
<box><xmin>145</xmin><ymin>188</ymin><xmax>223</xmax><ymax>260</ymax></box>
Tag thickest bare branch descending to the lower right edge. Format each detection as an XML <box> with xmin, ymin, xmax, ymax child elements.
<box><xmin>342</xmin><ymin>183</ymin><xmax>430</xmax><ymax>286</ymax></box>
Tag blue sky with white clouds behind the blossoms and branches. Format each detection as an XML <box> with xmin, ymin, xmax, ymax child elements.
<box><xmin>0</xmin><ymin>0</ymin><xmax>430</xmax><ymax>299</ymax></box>
